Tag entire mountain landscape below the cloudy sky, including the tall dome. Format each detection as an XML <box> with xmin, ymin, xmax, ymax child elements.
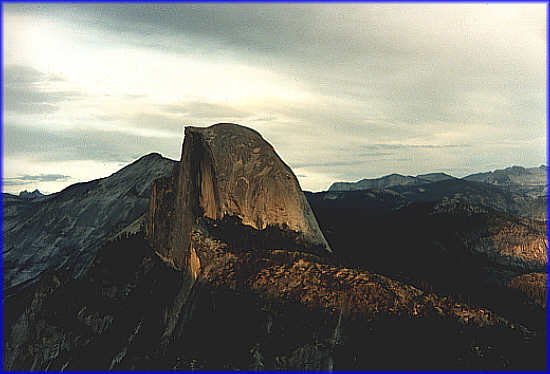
<box><xmin>3</xmin><ymin>124</ymin><xmax>548</xmax><ymax>371</ymax></box>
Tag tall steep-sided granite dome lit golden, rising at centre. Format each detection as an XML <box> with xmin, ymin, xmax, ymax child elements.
<box><xmin>146</xmin><ymin>123</ymin><xmax>332</xmax><ymax>269</ymax></box>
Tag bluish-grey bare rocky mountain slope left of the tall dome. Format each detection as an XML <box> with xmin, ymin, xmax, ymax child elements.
<box><xmin>2</xmin><ymin>153</ymin><xmax>175</xmax><ymax>290</ymax></box>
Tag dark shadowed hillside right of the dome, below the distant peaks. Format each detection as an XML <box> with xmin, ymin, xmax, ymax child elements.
<box><xmin>307</xmin><ymin>191</ymin><xmax>548</xmax><ymax>330</ymax></box>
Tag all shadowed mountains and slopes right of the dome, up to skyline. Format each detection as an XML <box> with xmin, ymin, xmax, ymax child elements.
<box><xmin>316</xmin><ymin>165</ymin><xmax>548</xmax><ymax>314</ymax></box>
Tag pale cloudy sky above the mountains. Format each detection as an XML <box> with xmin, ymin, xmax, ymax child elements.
<box><xmin>2</xmin><ymin>2</ymin><xmax>548</xmax><ymax>193</ymax></box>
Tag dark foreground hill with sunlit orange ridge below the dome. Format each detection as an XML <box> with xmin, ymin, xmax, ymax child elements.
<box><xmin>4</xmin><ymin>234</ymin><xmax>546</xmax><ymax>371</ymax></box>
